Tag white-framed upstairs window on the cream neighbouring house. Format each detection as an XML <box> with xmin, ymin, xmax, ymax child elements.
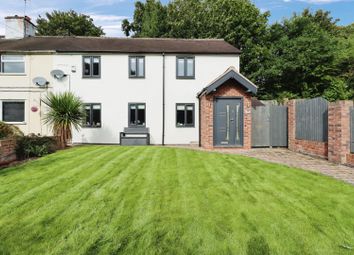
<box><xmin>0</xmin><ymin>55</ymin><xmax>25</xmax><ymax>74</ymax></box>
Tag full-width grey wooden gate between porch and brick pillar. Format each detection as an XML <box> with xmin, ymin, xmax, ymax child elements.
<box><xmin>252</xmin><ymin>100</ymin><xmax>288</xmax><ymax>147</ymax></box>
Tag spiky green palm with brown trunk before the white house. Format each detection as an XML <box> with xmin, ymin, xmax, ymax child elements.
<box><xmin>43</xmin><ymin>92</ymin><xmax>85</xmax><ymax>148</ymax></box>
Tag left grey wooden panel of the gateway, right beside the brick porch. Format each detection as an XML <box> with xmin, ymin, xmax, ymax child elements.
<box><xmin>251</xmin><ymin>102</ymin><xmax>270</xmax><ymax>147</ymax></box>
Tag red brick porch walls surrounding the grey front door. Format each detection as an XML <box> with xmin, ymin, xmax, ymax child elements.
<box><xmin>200</xmin><ymin>81</ymin><xmax>252</xmax><ymax>149</ymax></box>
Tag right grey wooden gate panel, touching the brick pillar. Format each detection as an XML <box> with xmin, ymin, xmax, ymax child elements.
<box><xmin>270</xmin><ymin>105</ymin><xmax>288</xmax><ymax>147</ymax></box>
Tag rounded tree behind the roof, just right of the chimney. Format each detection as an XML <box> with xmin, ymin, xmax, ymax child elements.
<box><xmin>37</xmin><ymin>10</ymin><xmax>104</xmax><ymax>36</ymax></box>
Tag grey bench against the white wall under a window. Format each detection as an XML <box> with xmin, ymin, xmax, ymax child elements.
<box><xmin>119</xmin><ymin>127</ymin><xmax>150</xmax><ymax>145</ymax></box>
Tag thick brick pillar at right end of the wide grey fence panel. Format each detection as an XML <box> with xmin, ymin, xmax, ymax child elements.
<box><xmin>328</xmin><ymin>101</ymin><xmax>353</xmax><ymax>164</ymax></box>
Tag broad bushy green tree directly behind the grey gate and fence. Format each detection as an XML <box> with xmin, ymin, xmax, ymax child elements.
<box><xmin>259</xmin><ymin>10</ymin><xmax>348</xmax><ymax>100</ymax></box>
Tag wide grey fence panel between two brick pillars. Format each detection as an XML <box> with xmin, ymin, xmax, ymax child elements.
<box><xmin>296</xmin><ymin>98</ymin><xmax>328</xmax><ymax>142</ymax></box>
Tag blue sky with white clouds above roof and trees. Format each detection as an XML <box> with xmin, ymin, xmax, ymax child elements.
<box><xmin>0</xmin><ymin>0</ymin><xmax>354</xmax><ymax>36</ymax></box>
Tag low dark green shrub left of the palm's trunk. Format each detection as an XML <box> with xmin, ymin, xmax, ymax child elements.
<box><xmin>16</xmin><ymin>135</ymin><xmax>57</xmax><ymax>159</ymax></box>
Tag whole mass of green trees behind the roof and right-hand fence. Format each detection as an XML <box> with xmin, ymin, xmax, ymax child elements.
<box><xmin>122</xmin><ymin>0</ymin><xmax>354</xmax><ymax>100</ymax></box>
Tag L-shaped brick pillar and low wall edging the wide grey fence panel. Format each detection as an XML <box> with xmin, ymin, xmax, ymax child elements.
<box><xmin>288</xmin><ymin>100</ymin><xmax>328</xmax><ymax>158</ymax></box>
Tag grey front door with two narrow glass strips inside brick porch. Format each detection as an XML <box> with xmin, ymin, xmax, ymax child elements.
<box><xmin>214</xmin><ymin>97</ymin><xmax>243</xmax><ymax>147</ymax></box>
